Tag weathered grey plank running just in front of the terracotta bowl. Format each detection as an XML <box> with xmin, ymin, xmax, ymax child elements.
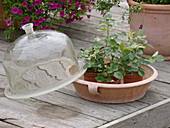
<box><xmin>36</xmin><ymin>92</ymin><xmax>127</xmax><ymax>120</ymax></box>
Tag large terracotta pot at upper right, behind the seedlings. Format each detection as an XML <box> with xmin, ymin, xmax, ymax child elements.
<box><xmin>127</xmin><ymin>0</ymin><xmax>170</xmax><ymax>60</ymax></box>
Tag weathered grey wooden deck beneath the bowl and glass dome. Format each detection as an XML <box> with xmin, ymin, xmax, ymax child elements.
<box><xmin>0</xmin><ymin>2</ymin><xmax>170</xmax><ymax>128</ymax></box>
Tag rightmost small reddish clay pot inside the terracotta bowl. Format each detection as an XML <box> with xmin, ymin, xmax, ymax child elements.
<box><xmin>124</xmin><ymin>75</ymin><xmax>143</xmax><ymax>84</ymax></box>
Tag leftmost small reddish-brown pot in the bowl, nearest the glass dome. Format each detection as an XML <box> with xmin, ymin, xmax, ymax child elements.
<box><xmin>84</xmin><ymin>72</ymin><xmax>98</xmax><ymax>82</ymax></box>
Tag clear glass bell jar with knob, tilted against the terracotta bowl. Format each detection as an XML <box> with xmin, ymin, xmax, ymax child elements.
<box><xmin>3</xmin><ymin>23</ymin><xmax>85</xmax><ymax>99</ymax></box>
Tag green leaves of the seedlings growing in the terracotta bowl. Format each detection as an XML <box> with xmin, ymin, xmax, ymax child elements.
<box><xmin>79</xmin><ymin>14</ymin><xmax>164</xmax><ymax>82</ymax></box>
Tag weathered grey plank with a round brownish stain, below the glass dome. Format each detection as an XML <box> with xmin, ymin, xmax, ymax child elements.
<box><xmin>0</xmin><ymin>96</ymin><xmax>104</xmax><ymax>128</ymax></box>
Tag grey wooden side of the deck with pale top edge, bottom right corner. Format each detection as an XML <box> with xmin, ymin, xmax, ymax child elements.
<box><xmin>99</xmin><ymin>98</ymin><xmax>170</xmax><ymax>128</ymax></box>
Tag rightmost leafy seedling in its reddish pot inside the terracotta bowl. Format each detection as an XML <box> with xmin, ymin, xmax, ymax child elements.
<box><xmin>116</xmin><ymin>29</ymin><xmax>164</xmax><ymax>83</ymax></box>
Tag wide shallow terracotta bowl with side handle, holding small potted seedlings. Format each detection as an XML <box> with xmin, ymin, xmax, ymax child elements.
<box><xmin>73</xmin><ymin>66</ymin><xmax>158</xmax><ymax>103</ymax></box>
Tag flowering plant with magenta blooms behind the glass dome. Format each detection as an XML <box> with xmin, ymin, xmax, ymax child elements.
<box><xmin>3</xmin><ymin>0</ymin><xmax>94</xmax><ymax>39</ymax></box>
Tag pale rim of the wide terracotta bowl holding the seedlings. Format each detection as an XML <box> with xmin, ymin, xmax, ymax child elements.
<box><xmin>75</xmin><ymin>65</ymin><xmax>158</xmax><ymax>88</ymax></box>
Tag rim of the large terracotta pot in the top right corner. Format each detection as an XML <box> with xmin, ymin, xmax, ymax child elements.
<box><xmin>127</xmin><ymin>0</ymin><xmax>170</xmax><ymax>11</ymax></box>
